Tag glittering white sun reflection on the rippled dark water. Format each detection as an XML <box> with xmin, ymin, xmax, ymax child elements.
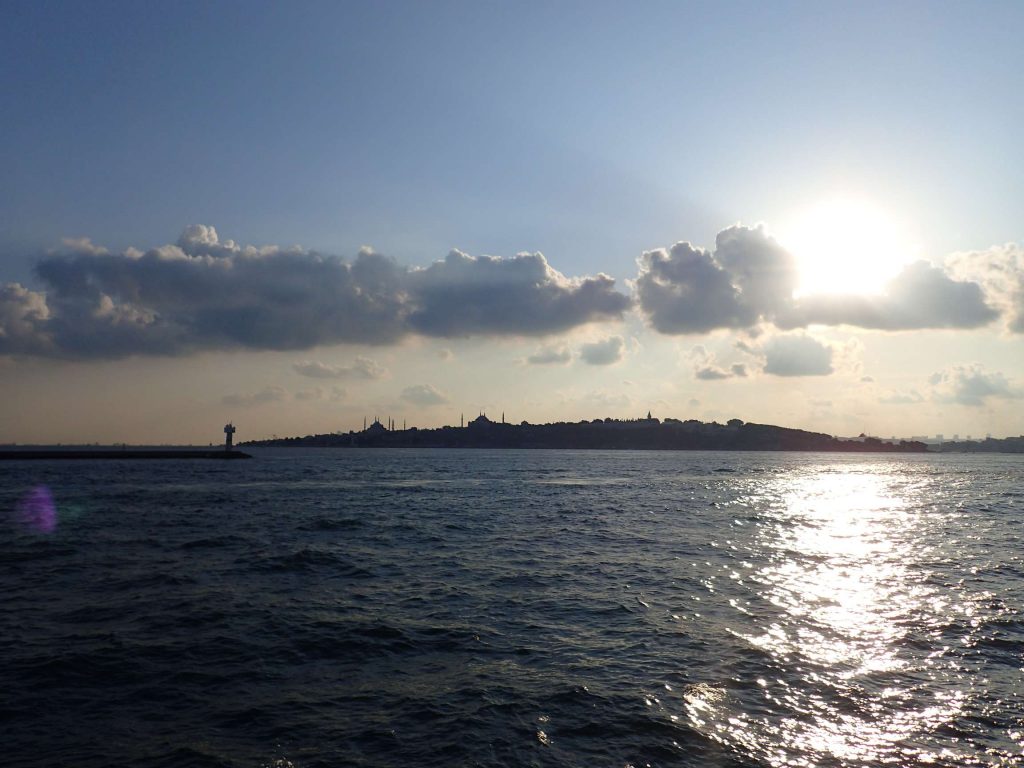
<box><xmin>684</xmin><ymin>470</ymin><xmax>987</xmax><ymax>768</ymax></box>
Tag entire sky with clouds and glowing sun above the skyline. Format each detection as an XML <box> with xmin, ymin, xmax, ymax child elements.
<box><xmin>0</xmin><ymin>0</ymin><xmax>1024</xmax><ymax>444</ymax></box>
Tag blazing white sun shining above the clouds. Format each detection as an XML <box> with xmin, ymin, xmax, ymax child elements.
<box><xmin>778</xmin><ymin>198</ymin><xmax>920</xmax><ymax>295</ymax></box>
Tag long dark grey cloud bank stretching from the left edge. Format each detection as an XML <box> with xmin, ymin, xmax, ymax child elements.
<box><xmin>0</xmin><ymin>225</ymin><xmax>631</xmax><ymax>358</ymax></box>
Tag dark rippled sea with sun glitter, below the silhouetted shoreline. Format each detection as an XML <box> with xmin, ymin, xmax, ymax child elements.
<box><xmin>0</xmin><ymin>450</ymin><xmax>1024</xmax><ymax>768</ymax></box>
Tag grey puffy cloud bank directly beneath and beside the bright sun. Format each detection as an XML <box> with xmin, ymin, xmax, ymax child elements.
<box><xmin>635</xmin><ymin>225</ymin><xmax>995</xmax><ymax>334</ymax></box>
